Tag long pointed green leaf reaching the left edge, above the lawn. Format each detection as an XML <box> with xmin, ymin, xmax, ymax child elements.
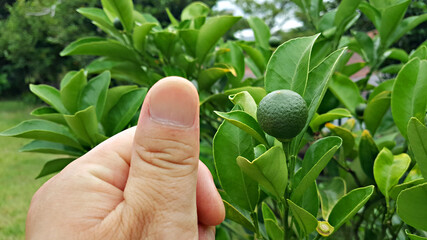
<box><xmin>0</xmin><ymin>119</ymin><xmax>81</xmax><ymax>149</ymax></box>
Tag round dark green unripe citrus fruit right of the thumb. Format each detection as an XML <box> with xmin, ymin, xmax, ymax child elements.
<box><xmin>257</xmin><ymin>90</ymin><xmax>308</xmax><ymax>141</ymax></box>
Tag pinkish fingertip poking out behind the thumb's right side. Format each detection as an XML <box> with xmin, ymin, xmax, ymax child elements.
<box><xmin>196</xmin><ymin>162</ymin><xmax>225</xmax><ymax>226</ymax></box>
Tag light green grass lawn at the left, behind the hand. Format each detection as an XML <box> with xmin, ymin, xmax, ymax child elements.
<box><xmin>0</xmin><ymin>101</ymin><xmax>54</xmax><ymax>240</ymax></box>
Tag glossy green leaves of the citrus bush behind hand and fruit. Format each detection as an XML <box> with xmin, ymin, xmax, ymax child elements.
<box><xmin>2</xmin><ymin>0</ymin><xmax>427</xmax><ymax>239</ymax></box>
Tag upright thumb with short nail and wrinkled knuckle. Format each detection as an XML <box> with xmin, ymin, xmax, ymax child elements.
<box><xmin>124</xmin><ymin>77</ymin><xmax>199</xmax><ymax>239</ymax></box>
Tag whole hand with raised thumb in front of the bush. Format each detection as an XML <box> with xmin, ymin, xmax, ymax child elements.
<box><xmin>26</xmin><ymin>77</ymin><xmax>225</xmax><ymax>240</ymax></box>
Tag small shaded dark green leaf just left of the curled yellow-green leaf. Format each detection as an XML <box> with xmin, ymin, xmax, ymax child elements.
<box><xmin>359</xmin><ymin>130</ymin><xmax>379</xmax><ymax>179</ymax></box>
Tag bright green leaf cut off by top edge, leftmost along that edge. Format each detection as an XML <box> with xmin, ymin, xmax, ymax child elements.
<box><xmin>101</xmin><ymin>0</ymin><xmax>134</xmax><ymax>33</ymax></box>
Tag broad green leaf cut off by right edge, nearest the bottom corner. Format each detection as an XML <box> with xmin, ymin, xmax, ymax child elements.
<box><xmin>397</xmin><ymin>183</ymin><xmax>427</xmax><ymax>231</ymax></box>
